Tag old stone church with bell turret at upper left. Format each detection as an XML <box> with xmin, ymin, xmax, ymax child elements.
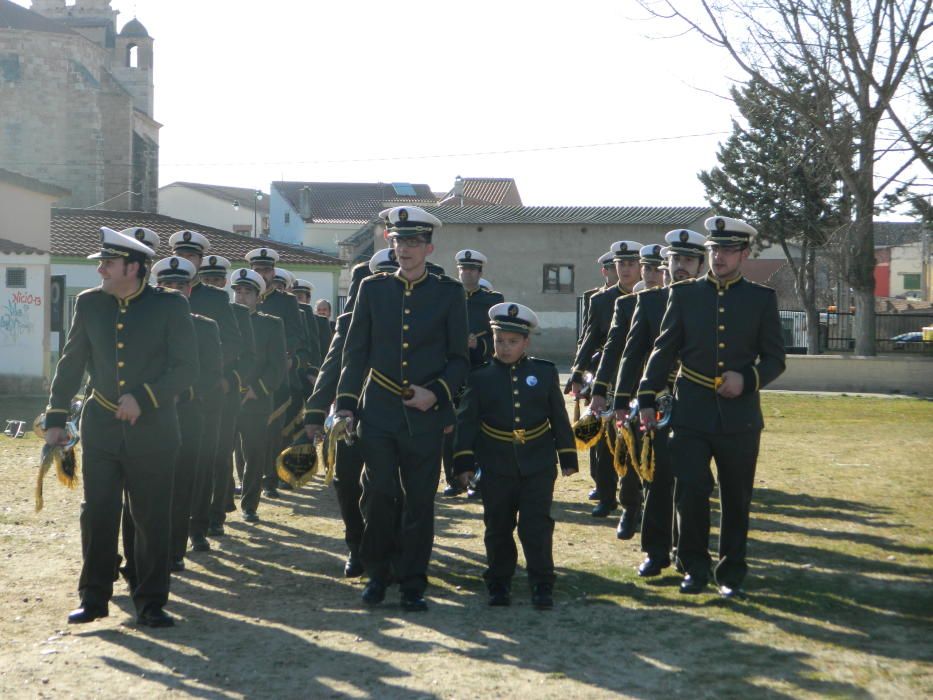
<box><xmin>0</xmin><ymin>0</ymin><xmax>161</xmax><ymax>211</ymax></box>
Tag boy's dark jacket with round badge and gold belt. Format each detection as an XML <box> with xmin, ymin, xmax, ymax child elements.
<box><xmin>454</xmin><ymin>357</ymin><xmax>577</xmax><ymax>476</ymax></box>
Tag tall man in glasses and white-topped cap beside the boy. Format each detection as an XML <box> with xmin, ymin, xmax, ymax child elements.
<box><xmin>336</xmin><ymin>207</ymin><xmax>469</xmax><ymax>610</ymax></box>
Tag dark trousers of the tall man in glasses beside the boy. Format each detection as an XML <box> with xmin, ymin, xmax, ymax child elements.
<box><xmin>358</xmin><ymin>420</ymin><xmax>443</xmax><ymax>594</ymax></box>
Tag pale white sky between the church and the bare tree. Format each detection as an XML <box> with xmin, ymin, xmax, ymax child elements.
<box><xmin>17</xmin><ymin>0</ymin><xmax>924</xmax><ymax>213</ymax></box>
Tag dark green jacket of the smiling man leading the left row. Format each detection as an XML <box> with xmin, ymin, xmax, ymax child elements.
<box><xmin>46</xmin><ymin>283</ymin><xmax>198</xmax><ymax>456</ymax></box>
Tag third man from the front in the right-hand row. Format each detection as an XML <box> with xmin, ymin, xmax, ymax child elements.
<box><xmin>591</xmin><ymin>241</ymin><xmax>663</xmax><ymax>540</ymax></box>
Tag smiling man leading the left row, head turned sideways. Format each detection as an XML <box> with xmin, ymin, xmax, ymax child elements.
<box><xmin>45</xmin><ymin>228</ymin><xmax>198</xmax><ymax>627</ymax></box>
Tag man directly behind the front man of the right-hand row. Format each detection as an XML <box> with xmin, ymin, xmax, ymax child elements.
<box><xmin>613</xmin><ymin>229</ymin><xmax>706</xmax><ymax>577</ymax></box>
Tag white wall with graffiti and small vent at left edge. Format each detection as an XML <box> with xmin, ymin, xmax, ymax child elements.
<box><xmin>0</xmin><ymin>253</ymin><xmax>49</xmax><ymax>379</ymax></box>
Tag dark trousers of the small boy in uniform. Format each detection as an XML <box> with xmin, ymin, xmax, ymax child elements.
<box><xmin>482</xmin><ymin>464</ymin><xmax>557</xmax><ymax>586</ymax></box>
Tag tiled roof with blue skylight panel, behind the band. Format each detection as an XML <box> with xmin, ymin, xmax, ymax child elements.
<box><xmin>272</xmin><ymin>182</ymin><xmax>437</xmax><ymax>224</ymax></box>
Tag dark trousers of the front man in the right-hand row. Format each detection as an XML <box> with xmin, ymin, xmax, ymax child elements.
<box><xmin>670</xmin><ymin>428</ymin><xmax>761</xmax><ymax>588</ymax></box>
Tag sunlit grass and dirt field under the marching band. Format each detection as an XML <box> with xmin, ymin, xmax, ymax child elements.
<box><xmin>0</xmin><ymin>394</ymin><xmax>933</xmax><ymax>698</ymax></box>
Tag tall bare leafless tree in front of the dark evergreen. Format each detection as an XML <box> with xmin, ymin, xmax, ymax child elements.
<box><xmin>639</xmin><ymin>0</ymin><xmax>933</xmax><ymax>355</ymax></box>
